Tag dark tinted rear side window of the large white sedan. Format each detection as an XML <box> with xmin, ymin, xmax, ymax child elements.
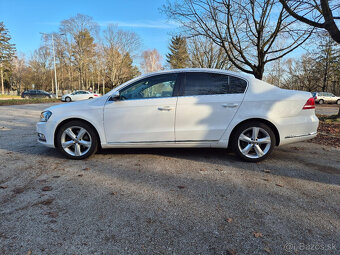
<box><xmin>182</xmin><ymin>72</ymin><xmax>247</xmax><ymax>96</ymax></box>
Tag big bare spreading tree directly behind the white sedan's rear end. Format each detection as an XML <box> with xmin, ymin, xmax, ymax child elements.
<box><xmin>163</xmin><ymin>0</ymin><xmax>310</xmax><ymax>79</ymax></box>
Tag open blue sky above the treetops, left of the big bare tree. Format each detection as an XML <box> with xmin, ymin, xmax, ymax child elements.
<box><xmin>0</xmin><ymin>0</ymin><xmax>177</xmax><ymax>62</ymax></box>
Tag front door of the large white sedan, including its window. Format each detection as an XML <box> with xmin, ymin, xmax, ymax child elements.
<box><xmin>104</xmin><ymin>73</ymin><xmax>178</xmax><ymax>143</ymax></box>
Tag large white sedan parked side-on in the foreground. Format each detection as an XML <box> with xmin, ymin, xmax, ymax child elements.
<box><xmin>37</xmin><ymin>69</ymin><xmax>319</xmax><ymax>162</ymax></box>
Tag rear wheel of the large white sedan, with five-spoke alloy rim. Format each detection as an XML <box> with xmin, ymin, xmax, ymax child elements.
<box><xmin>231</xmin><ymin>121</ymin><xmax>276</xmax><ymax>162</ymax></box>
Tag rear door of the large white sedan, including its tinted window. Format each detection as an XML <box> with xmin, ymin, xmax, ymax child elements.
<box><xmin>175</xmin><ymin>72</ymin><xmax>247</xmax><ymax>142</ymax></box>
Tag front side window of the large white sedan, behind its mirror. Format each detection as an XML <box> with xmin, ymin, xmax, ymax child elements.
<box><xmin>120</xmin><ymin>74</ymin><xmax>177</xmax><ymax>100</ymax></box>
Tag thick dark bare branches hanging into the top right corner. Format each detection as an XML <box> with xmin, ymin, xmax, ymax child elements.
<box><xmin>279</xmin><ymin>0</ymin><xmax>340</xmax><ymax>43</ymax></box>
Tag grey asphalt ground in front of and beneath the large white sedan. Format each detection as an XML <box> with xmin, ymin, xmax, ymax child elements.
<box><xmin>0</xmin><ymin>102</ymin><xmax>340</xmax><ymax>255</ymax></box>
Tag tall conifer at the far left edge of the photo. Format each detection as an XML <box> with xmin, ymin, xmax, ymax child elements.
<box><xmin>0</xmin><ymin>22</ymin><xmax>15</xmax><ymax>94</ymax></box>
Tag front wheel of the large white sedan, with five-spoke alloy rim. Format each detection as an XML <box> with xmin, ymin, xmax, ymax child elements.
<box><xmin>56</xmin><ymin>120</ymin><xmax>99</xmax><ymax>160</ymax></box>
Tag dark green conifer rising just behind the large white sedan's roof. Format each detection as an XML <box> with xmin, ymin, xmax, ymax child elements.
<box><xmin>166</xmin><ymin>36</ymin><xmax>189</xmax><ymax>69</ymax></box>
